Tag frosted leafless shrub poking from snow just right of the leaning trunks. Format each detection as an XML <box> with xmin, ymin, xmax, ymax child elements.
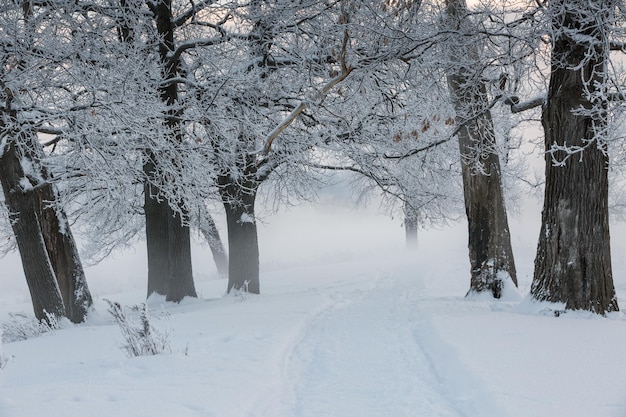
<box><xmin>104</xmin><ymin>300</ymin><xmax>171</xmax><ymax>358</ymax></box>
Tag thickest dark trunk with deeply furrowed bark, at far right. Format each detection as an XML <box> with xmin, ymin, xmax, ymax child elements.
<box><xmin>531</xmin><ymin>0</ymin><xmax>618</xmax><ymax>314</ymax></box>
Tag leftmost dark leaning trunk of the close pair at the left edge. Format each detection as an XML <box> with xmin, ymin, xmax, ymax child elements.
<box><xmin>0</xmin><ymin>142</ymin><xmax>65</xmax><ymax>321</ymax></box>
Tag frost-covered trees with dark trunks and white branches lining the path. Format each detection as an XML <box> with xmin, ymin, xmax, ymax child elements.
<box><xmin>0</xmin><ymin>0</ymin><xmax>626</xmax><ymax>322</ymax></box>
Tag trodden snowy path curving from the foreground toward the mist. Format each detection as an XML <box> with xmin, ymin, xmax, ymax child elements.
<box><xmin>278</xmin><ymin>268</ymin><xmax>505</xmax><ymax>417</ymax></box>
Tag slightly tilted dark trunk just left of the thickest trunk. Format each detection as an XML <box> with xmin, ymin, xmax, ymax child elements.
<box><xmin>447</xmin><ymin>0</ymin><xmax>517</xmax><ymax>298</ymax></box>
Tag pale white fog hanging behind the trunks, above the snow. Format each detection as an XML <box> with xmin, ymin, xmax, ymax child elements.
<box><xmin>0</xmin><ymin>182</ymin><xmax>626</xmax><ymax>313</ymax></box>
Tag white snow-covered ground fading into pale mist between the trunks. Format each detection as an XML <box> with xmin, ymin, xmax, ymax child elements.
<box><xmin>0</xmin><ymin>199</ymin><xmax>626</xmax><ymax>417</ymax></box>
